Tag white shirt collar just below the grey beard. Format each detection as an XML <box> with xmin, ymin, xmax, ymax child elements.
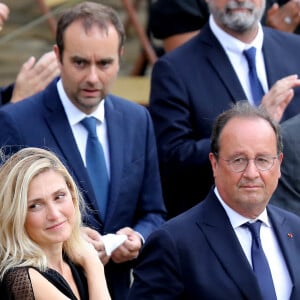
<box><xmin>209</xmin><ymin>15</ymin><xmax>264</xmax><ymax>54</ymax></box>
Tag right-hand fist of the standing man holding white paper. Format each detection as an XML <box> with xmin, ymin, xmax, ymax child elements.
<box><xmin>111</xmin><ymin>227</ymin><xmax>142</xmax><ymax>263</ymax></box>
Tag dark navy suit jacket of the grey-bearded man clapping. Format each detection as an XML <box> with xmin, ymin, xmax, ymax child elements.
<box><xmin>150</xmin><ymin>25</ymin><xmax>300</xmax><ymax>216</ymax></box>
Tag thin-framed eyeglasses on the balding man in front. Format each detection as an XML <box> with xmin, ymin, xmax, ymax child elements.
<box><xmin>216</xmin><ymin>154</ymin><xmax>278</xmax><ymax>173</ymax></box>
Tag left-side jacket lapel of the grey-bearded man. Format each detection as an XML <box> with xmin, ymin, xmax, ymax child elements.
<box><xmin>198</xmin><ymin>24</ymin><xmax>247</xmax><ymax>102</ymax></box>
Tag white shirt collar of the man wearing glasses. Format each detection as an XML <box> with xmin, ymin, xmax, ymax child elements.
<box><xmin>214</xmin><ymin>187</ymin><xmax>272</xmax><ymax>229</ymax></box>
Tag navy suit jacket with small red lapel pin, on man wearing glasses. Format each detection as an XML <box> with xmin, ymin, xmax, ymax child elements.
<box><xmin>128</xmin><ymin>191</ymin><xmax>300</xmax><ymax>300</ymax></box>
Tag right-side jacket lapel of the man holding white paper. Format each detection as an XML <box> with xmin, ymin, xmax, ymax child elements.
<box><xmin>105</xmin><ymin>95</ymin><xmax>126</xmax><ymax>220</ymax></box>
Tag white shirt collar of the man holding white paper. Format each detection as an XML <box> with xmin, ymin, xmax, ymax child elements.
<box><xmin>57</xmin><ymin>79</ymin><xmax>105</xmax><ymax>126</ymax></box>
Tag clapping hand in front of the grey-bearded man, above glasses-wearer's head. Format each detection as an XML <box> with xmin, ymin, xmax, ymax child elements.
<box><xmin>261</xmin><ymin>75</ymin><xmax>300</xmax><ymax>122</ymax></box>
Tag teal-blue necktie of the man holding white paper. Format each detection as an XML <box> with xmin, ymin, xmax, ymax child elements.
<box><xmin>81</xmin><ymin>117</ymin><xmax>109</xmax><ymax>221</ymax></box>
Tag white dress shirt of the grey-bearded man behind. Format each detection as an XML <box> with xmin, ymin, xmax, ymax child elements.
<box><xmin>209</xmin><ymin>15</ymin><xmax>269</xmax><ymax>104</ymax></box>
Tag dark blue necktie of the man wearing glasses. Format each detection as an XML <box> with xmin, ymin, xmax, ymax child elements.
<box><xmin>245</xmin><ymin>221</ymin><xmax>277</xmax><ymax>300</ymax></box>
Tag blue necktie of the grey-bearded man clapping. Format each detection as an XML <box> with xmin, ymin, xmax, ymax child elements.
<box><xmin>244</xmin><ymin>47</ymin><xmax>265</xmax><ymax>106</ymax></box>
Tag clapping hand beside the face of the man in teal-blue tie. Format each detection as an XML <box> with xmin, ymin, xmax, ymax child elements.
<box><xmin>10</xmin><ymin>51</ymin><xmax>60</xmax><ymax>102</ymax></box>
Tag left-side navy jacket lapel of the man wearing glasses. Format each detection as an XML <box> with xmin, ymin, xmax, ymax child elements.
<box><xmin>198</xmin><ymin>192</ymin><xmax>261</xmax><ymax>300</ymax></box>
